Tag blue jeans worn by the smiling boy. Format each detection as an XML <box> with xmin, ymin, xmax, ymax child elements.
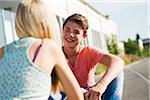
<box><xmin>48</xmin><ymin>72</ymin><xmax>124</xmax><ymax>100</ymax></box>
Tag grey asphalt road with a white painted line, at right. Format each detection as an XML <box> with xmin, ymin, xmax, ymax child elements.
<box><xmin>123</xmin><ymin>58</ymin><xmax>150</xmax><ymax>100</ymax></box>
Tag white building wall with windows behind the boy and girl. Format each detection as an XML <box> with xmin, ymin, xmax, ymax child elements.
<box><xmin>0</xmin><ymin>0</ymin><xmax>117</xmax><ymax>51</ymax></box>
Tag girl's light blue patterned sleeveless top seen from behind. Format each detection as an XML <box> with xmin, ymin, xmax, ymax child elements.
<box><xmin>0</xmin><ymin>38</ymin><xmax>52</xmax><ymax>100</ymax></box>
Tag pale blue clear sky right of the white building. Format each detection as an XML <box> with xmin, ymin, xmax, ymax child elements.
<box><xmin>85</xmin><ymin>0</ymin><xmax>150</xmax><ymax>41</ymax></box>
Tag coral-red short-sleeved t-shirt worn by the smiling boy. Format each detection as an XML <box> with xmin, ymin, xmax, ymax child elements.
<box><xmin>68</xmin><ymin>46</ymin><xmax>105</xmax><ymax>87</ymax></box>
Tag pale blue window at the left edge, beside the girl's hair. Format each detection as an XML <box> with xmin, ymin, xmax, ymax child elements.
<box><xmin>0</xmin><ymin>8</ymin><xmax>18</xmax><ymax>46</ymax></box>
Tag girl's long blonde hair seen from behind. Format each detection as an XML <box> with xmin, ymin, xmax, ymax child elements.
<box><xmin>15</xmin><ymin>0</ymin><xmax>56</xmax><ymax>39</ymax></box>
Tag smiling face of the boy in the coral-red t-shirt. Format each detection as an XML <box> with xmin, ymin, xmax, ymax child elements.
<box><xmin>63</xmin><ymin>21</ymin><xmax>86</xmax><ymax>47</ymax></box>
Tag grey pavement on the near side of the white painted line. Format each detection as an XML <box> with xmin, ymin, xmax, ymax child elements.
<box><xmin>123</xmin><ymin>68</ymin><xmax>149</xmax><ymax>100</ymax></box>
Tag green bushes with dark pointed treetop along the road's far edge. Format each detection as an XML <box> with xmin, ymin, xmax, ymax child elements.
<box><xmin>123</xmin><ymin>33</ymin><xmax>150</xmax><ymax>64</ymax></box>
